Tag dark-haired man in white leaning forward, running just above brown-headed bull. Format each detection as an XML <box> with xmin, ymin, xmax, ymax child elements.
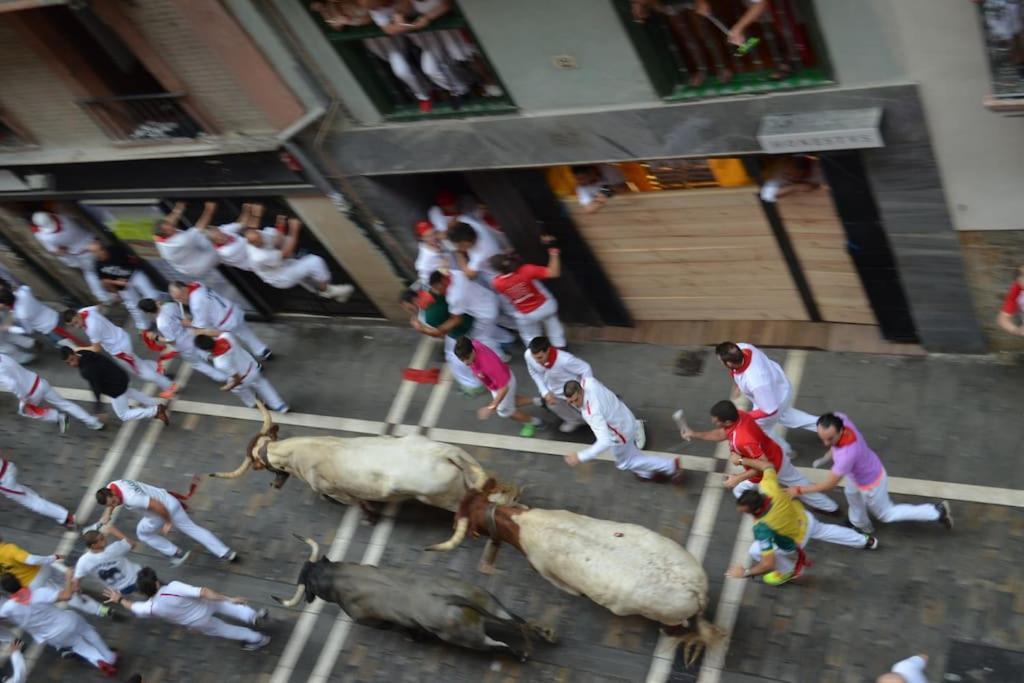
<box><xmin>562</xmin><ymin>377</ymin><xmax>683</xmax><ymax>484</ymax></box>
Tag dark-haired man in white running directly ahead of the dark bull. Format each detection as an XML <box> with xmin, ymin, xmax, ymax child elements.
<box><xmin>103</xmin><ymin>567</ymin><xmax>270</xmax><ymax>650</ymax></box>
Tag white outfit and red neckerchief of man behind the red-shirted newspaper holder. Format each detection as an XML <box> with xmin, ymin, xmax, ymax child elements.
<box><xmin>729</xmin><ymin>344</ymin><xmax>818</xmax><ymax>456</ymax></box>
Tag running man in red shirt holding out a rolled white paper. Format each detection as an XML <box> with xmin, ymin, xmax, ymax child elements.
<box><xmin>682</xmin><ymin>400</ymin><xmax>839</xmax><ymax>512</ymax></box>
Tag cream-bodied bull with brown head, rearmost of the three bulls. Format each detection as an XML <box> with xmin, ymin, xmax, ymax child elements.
<box><xmin>427</xmin><ymin>492</ymin><xmax>723</xmax><ymax>666</ymax></box>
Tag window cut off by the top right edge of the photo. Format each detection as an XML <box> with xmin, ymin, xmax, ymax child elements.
<box><xmin>978</xmin><ymin>0</ymin><xmax>1024</xmax><ymax>109</ymax></box>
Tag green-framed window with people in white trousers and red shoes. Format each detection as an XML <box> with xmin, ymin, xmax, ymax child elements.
<box><xmin>309</xmin><ymin>0</ymin><xmax>515</xmax><ymax>121</ymax></box>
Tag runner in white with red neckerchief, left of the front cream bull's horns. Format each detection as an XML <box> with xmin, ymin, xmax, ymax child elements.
<box><xmin>96</xmin><ymin>479</ymin><xmax>238</xmax><ymax>566</ymax></box>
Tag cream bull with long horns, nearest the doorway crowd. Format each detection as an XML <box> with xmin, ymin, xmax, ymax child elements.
<box><xmin>210</xmin><ymin>402</ymin><xmax>517</xmax><ymax>515</ymax></box>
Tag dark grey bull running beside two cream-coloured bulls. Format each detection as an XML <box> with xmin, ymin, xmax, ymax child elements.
<box><xmin>274</xmin><ymin>533</ymin><xmax>555</xmax><ymax>660</ymax></box>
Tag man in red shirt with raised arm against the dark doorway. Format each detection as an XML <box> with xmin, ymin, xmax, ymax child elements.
<box><xmin>490</xmin><ymin>242</ymin><xmax>565</xmax><ymax>348</ymax></box>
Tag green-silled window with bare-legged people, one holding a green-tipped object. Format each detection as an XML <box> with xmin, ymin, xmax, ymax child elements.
<box><xmin>612</xmin><ymin>0</ymin><xmax>830</xmax><ymax>100</ymax></box>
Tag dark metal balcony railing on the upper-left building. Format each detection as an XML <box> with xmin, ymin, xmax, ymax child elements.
<box><xmin>78</xmin><ymin>92</ymin><xmax>205</xmax><ymax>142</ymax></box>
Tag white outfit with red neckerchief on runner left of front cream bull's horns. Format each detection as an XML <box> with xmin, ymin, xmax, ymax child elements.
<box><xmin>106</xmin><ymin>479</ymin><xmax>231</xmax><ymax>558</ymax></box>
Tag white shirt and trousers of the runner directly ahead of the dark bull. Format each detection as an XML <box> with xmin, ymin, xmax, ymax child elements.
<box><xmin>131</xmin><ymin>581</ymin><xmax>263</xmax><ymax>644</ymax></box>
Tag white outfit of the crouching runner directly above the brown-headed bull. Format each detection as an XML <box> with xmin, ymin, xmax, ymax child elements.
<box><xmin>579</xmin><ymin>377</ymin><xmax>676</xmax><ymax>479</ymax></box>
